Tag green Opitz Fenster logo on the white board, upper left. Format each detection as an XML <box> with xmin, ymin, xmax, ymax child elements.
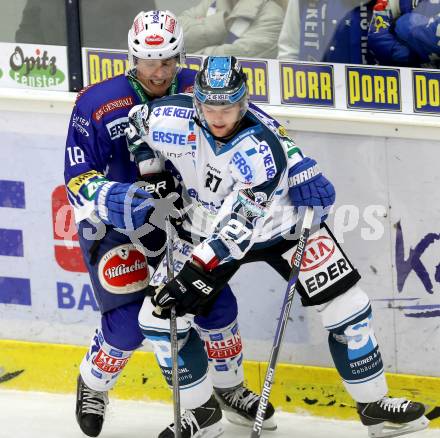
<box><xmin>9</xmin><ymin>46</ymin><xmax>66</xmax><ymax>88</ymax></box>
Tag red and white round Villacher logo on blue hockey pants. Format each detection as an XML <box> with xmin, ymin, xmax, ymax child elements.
<box><xmin>98</xmin><ymin>243</ymin><xmax>149</xmax><ymax>294</ymax></box>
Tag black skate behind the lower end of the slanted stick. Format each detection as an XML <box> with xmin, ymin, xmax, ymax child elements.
<box><xmin>214</xmin><ymin>385</ymin><xmax>277</xmax><ymax>430</ymax></box>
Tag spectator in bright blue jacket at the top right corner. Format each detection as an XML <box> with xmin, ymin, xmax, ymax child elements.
<box><xmin>368</xmin><ymin>0</ymin><xmax>440</xmax><ymax>68</ymax></box>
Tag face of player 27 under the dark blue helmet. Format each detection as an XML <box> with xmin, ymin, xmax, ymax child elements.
<box><xmin>202</xmin><ymin>103</ymin><xmax>240</xmax><ymax>137</ymax></box>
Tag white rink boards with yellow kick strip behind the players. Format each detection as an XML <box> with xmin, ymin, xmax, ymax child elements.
<box><xmin>0</xmin><ymin>90</ymin><xmax>440</xmax><ymax>432</ymax></box>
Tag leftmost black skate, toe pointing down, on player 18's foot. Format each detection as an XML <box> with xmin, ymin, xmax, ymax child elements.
<box><xmin>76</xmin><ymin>375</ymin><xmax>108</xmax><ymax>436</ymax></box>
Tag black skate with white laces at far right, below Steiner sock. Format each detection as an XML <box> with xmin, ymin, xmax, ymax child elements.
<box><xmin>357</xmin><ymin>397</ymin><xmax>429</xmax><ymax>438</ymax></box>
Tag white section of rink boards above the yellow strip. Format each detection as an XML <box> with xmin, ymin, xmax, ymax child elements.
<box><xmin>0</xmin><ymin>105</ymin><xmax>440</xmax><ymax>377</ymax></box>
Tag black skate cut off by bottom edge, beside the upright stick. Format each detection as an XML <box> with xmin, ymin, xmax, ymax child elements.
<box><xmin>159</xmin><ymin>395</ymin><xmax>223</xmax><ymax>438</ymax></box>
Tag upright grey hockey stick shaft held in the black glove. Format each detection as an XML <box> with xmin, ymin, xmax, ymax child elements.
<box><xmin>165</xmin><ymin>216</ymin><xmax>182</xmax><ymax>438</ymax></box>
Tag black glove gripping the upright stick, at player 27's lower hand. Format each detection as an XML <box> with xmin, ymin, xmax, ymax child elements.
<box><xmin>151</xmin><ymin>262</ymin><xmax>221</xmax><ymax>319</ymax></box>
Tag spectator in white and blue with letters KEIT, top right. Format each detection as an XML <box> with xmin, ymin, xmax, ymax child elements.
<box><xmin>278</xmin><ymin>0</ymin><xmax>375</xmax><ymax>64</ymax></box>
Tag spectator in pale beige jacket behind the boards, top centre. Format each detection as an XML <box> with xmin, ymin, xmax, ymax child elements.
<box><xmin>179</xmin><ymin>0</ymin><xmax>284</xmax><ymax>58</ymax></box>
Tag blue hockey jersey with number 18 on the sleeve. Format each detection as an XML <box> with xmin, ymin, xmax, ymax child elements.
<box><xmin>64</xmin><ymin>69</ymin><xmax>196</xmax><ymax>226</ymax></box>
